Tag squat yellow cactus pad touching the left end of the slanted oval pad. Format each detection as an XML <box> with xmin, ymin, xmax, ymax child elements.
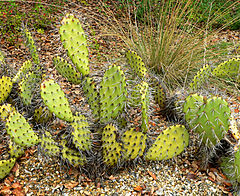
<box><xmin>121</xmin><ymin>128</ymin><xmax>147</xmax><ymax>160</ymax></box>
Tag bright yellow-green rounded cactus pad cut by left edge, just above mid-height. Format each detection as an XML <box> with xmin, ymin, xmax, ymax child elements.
<box><xmin>0</xmin><ymin>76</ymin><xmax>13</xmax><ymax>103</ymax></box>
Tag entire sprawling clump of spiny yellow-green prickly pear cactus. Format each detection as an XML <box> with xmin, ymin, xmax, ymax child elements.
<box><xmin>0</xmin><ymin>14</ymin><xmax>239</xmax><ymax>194</ymax></box>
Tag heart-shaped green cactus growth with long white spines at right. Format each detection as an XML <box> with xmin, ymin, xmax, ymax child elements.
<box><xmin>183</xmin><ymin>95</ymin><xmax>231</xmax><ymax>148</ymax></box>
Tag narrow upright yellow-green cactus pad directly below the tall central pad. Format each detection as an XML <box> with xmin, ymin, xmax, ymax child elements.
<box><xmin>102</xmin><ymin>124</ymin><xmax>122</xmax><ymax>166</ymax></box>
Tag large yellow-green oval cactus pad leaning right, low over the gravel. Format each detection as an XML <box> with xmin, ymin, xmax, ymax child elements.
<box><xmin>145</xmin><ymin>125</ymin><xmax>189</xmax><ymax>161</ymax></box>
